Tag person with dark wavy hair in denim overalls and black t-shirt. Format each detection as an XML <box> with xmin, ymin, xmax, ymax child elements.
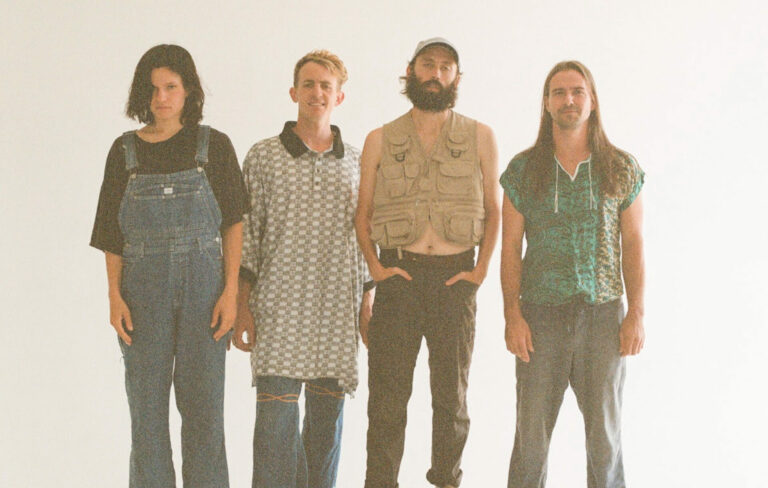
<box><xmin>92</xmin><ymin>45</ymin><xmax>248</xmax><ymax>488</ymax></box>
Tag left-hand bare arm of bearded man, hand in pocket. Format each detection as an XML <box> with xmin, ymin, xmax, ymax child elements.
<box><xmin>355</xmin><ymin>128</ymin><xmax>411</xmax><ymax>281</ymax></box>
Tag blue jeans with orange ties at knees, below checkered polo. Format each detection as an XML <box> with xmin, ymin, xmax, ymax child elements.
<box><xmin>253</xmin><ymin>376</ymin><xmax>344</xmax><ymax>488</ymax></box>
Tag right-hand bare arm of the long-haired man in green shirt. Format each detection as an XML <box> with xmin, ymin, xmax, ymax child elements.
<box><xmin>619</xmin><ymin>193</ymin><xmax>645</xmax><ymax>356</ymax></box>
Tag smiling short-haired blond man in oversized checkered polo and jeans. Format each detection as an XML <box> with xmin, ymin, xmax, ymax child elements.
<box><xmin>233</xmin><ymin>51</ymin><xmax>372</xmax><ymax>488</ymax></box>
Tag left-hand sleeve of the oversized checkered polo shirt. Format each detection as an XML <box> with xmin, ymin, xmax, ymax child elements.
<box><xmin>240</xmin><ymin>146</ymin><xmax>266</xmax><ymax>283</ymax></box>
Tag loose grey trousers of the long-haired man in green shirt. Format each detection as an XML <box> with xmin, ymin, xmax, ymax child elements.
<box><xmin>508</xmin><ymin>300</ymin><xmax>625</xmax><ymax>488</ymax></box>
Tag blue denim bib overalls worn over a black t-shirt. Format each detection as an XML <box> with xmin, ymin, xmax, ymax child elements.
<box><xmin>119</xmin><ymin>126</ymin><xmax>229</xmax><ymax>488</ymax></box>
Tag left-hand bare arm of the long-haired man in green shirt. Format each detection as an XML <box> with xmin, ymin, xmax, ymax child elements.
<box><xmin>501</xmin><ymin>196</ymin><xmax>533</xmax><ymax>363</ymax></box>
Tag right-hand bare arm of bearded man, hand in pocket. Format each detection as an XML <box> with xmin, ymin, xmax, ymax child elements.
<box><xmin>445</xmin><ymin>123</ymin><xmax>500</xmax><ymax>286</ymax></box>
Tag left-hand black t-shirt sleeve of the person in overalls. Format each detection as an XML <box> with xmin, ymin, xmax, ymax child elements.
<box><xmin>91</xmin><ymin>137</ymin><xmax>128</xmax><ymax>255</ymax></box>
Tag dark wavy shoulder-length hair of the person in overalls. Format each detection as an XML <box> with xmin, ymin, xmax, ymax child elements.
<box><xmin>125</xmin><ymin>44</ymin><xmax>205</xmax><ymax>125</ymax></box>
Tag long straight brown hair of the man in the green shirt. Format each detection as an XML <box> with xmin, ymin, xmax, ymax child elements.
<box><xmin>521</xmin><ymin>61</ymin><xmax>632</xmax><ymax>197</ymax></box>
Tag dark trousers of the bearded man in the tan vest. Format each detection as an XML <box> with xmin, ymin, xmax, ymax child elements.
<box><xmin>365</xmin><ymin>251</ymin><xmax>477</xmax><ymax>488</ymax></box>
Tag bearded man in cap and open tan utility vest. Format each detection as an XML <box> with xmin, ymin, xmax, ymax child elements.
<box><xmin>355</xmin><ymin>38</ymin><xmax>500</xmax><ymax>488</ymax></box>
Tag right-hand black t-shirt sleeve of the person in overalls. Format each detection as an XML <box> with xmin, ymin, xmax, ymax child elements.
<box><xmin>206</xmin><ymin>130</ymin><xmax>251</xmax><ymax>232</ymax></box>
